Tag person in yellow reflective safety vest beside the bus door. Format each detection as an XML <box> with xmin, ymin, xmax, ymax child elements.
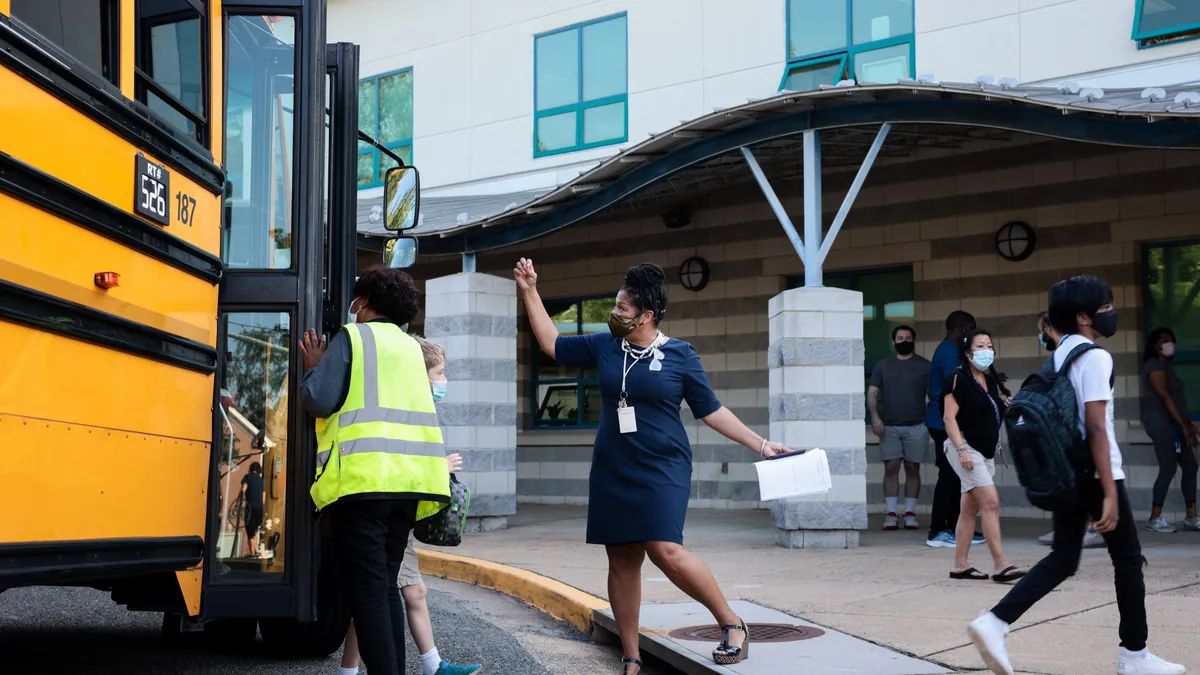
<box><xmin>300</xmin><ymin>267</ymin><xmax>450</xmax><ymax>675</ymax></box>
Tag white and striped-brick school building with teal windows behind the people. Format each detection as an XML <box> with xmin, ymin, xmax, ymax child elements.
<box><xmin>330</xmin><ymin>0</ymin><xmax>1200</xmax><ymax>546</ymax></box>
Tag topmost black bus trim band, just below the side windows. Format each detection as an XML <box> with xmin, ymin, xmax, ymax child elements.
<box><xmin>0</xmin><ymin>14</ymin><xmax>226</xmax><ymax>195</ymax></box>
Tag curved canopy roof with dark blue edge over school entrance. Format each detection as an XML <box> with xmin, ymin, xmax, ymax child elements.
<box><xmin>400</xmin><ymin>78</ymin><xmax>1200</xmax><ymax>255</ymax></box>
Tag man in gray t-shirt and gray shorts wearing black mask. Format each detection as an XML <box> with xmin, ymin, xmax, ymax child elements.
<box><xmin>866</xmin><ymin>325</ymin><xmax>929</xmax><ymax>530</ymax></box>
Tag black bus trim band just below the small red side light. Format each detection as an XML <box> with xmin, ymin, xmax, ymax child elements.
<box><xmin>0</xmin><ymin>279</ymin><xmax>217</xmax><ymax>375</ymax></box>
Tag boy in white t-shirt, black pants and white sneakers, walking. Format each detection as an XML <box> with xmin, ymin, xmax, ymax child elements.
<box><xmin>967</xmin><ymin>275</ymin><xmax>1187</xmax><ymax>675</ymax></box>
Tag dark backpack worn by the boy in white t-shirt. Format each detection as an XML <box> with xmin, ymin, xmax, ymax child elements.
<box><xmin>1004</xmin><ymin>344</ymin><xmax>1100</xmax><ymax>512</ymax></box>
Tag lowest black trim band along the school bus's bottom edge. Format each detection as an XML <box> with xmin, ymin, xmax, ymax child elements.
<box><xmin>0</xmin><ymin>536</ymin><xmax>204</xmax><ymax>589</ymax></box>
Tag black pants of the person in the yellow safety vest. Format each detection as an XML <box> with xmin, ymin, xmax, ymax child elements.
<box><xmin>329</xmin><ymin>498</ymin><xmax>416</xmax><ymax>675</ymax></box>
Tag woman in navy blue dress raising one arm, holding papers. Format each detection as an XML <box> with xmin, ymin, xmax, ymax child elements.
<box><xmin>514</xmin><ymin>258</ymin><xmax>787</xmax><ymax>675</ymax></box>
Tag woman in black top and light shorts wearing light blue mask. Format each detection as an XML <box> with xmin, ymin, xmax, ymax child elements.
<box><xmin>942</xmin><ymin>329</ymin><xmax>1025</xmax><ymax>584</ymax></box>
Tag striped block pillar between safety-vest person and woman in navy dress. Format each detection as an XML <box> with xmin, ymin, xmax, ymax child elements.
<box><xmin>425</xmin><ymin>273</ymin><xmax>517</xmax><ymax>531</ymax></box>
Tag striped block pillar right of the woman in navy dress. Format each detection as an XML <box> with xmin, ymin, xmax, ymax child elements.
<box><xmin>768</xmin><ymin>288</ymin><xmax>866</xmax><ymax>549</ymax></box>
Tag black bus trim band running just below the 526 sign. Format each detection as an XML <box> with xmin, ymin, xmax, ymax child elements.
<box><xmin>0</xmin><ymin>151</ymin><xmax>224</xmax><ymax>285</ymax></box>
